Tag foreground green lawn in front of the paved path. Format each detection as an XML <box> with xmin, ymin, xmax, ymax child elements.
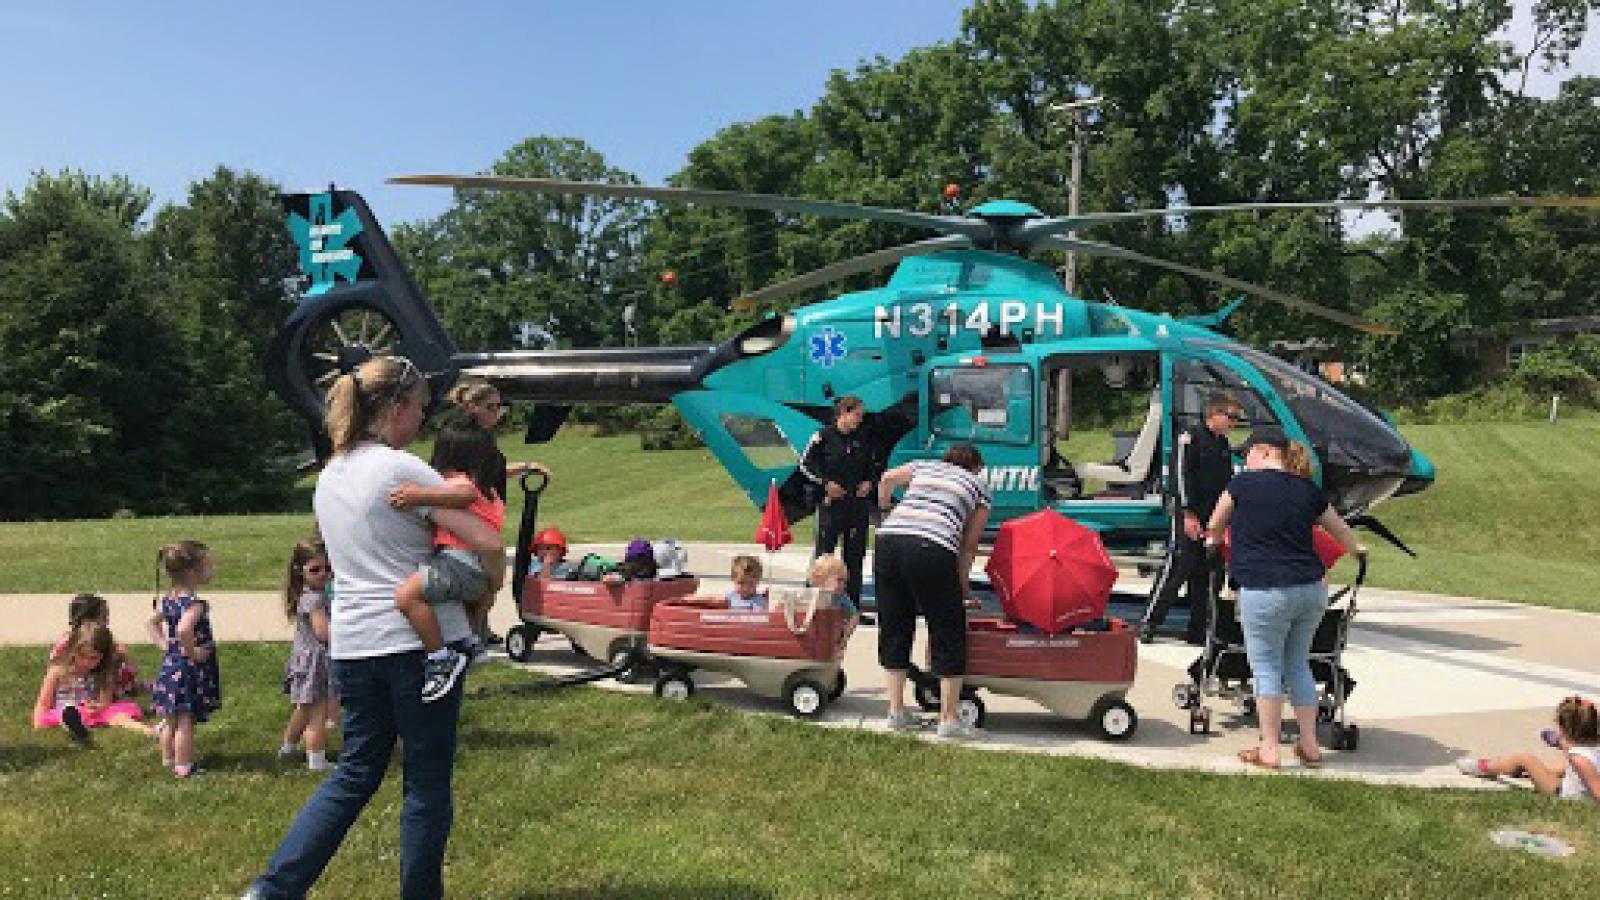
<box><xmin>0</xmin><ymin>644</ymin><xmax>1600</xmax><ymax>900</ymax></box>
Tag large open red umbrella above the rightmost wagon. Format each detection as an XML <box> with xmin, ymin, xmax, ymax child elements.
<box><xmin>986</xmin><ymin>509</ymin><xmax>1117</xmax><ymax>634</ymax></box>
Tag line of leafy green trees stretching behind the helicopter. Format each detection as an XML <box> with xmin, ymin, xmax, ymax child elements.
<box><xmin>0</xmin><ymin>0</ymin><xmax>1600</xmax><ymax>519</ymax></box>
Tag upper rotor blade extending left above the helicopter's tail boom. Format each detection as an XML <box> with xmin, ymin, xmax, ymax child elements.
<box><xmin>389</xmin><ymin>175</ymin><xmax>994</xmax><ymax>243</ymax></box>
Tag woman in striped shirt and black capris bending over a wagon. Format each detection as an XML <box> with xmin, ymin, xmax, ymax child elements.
<box><xmin>872</xmin><ymin>444</ymin><xmax>990</xmax><ymax>738</ymax></box>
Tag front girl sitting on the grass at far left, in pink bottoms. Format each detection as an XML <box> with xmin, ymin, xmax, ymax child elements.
<box><xmin>34</xmin><ymin>621</ymin><xmax>152</xmax><ymax>743</ymax></box>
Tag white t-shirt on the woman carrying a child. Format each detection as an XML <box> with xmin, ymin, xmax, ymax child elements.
<box><xmin>312</xmin><ymin>444</ymin><xmax>467</xmax><ymax>660</ymax></box>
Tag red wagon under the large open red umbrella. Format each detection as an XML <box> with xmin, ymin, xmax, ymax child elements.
<box><xmin>910</xmin><ymin>618</ymin><xmax>1139</xmax><ymax>740</ymax></box>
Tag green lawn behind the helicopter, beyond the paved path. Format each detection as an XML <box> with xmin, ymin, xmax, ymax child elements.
<box><xmin>0</xmin><ymin>418</ymin><xmax>1600</xmax><ymax>610</ymax></box>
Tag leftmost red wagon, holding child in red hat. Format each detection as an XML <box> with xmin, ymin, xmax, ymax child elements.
<box><xmin>506</xmin><ymin>575</ymin><xmax>699</xmax><ymax>669</ymax></box>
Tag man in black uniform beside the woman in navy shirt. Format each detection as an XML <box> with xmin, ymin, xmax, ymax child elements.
<box><xmin>1139</xmin><ymin>394</ymin><xmax>1243</xmax><ymax>644</ymax></box>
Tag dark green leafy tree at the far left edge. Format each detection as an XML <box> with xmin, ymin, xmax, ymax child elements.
<box><xmin>0</xmin><ymin>171</ymin><xmax>182</xmax><ymax>519</ymax></box>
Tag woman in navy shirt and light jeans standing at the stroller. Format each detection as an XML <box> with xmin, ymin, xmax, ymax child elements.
<box><xmin>1206</xmin><ymin>431</ymin><xmax>1366</xmax><ymax>769</ymax></box>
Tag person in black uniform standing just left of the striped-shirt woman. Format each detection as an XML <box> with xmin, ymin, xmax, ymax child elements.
<box><xmin>800</xmin><ymin>394</ymin><xmax>882</xmax><ymax>609</ymax></box>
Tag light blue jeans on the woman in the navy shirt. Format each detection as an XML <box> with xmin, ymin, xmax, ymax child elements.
<box><xmin>1238</xmin><ymin>581</ymin><xmax>1328</xmax><ymax>706</ymax></box>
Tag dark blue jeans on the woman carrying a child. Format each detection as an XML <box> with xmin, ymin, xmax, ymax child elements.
<box><xmin>253</xmin><ymin>650</ymin><xmax>466</xmax><ymax>900</ymax></box>
